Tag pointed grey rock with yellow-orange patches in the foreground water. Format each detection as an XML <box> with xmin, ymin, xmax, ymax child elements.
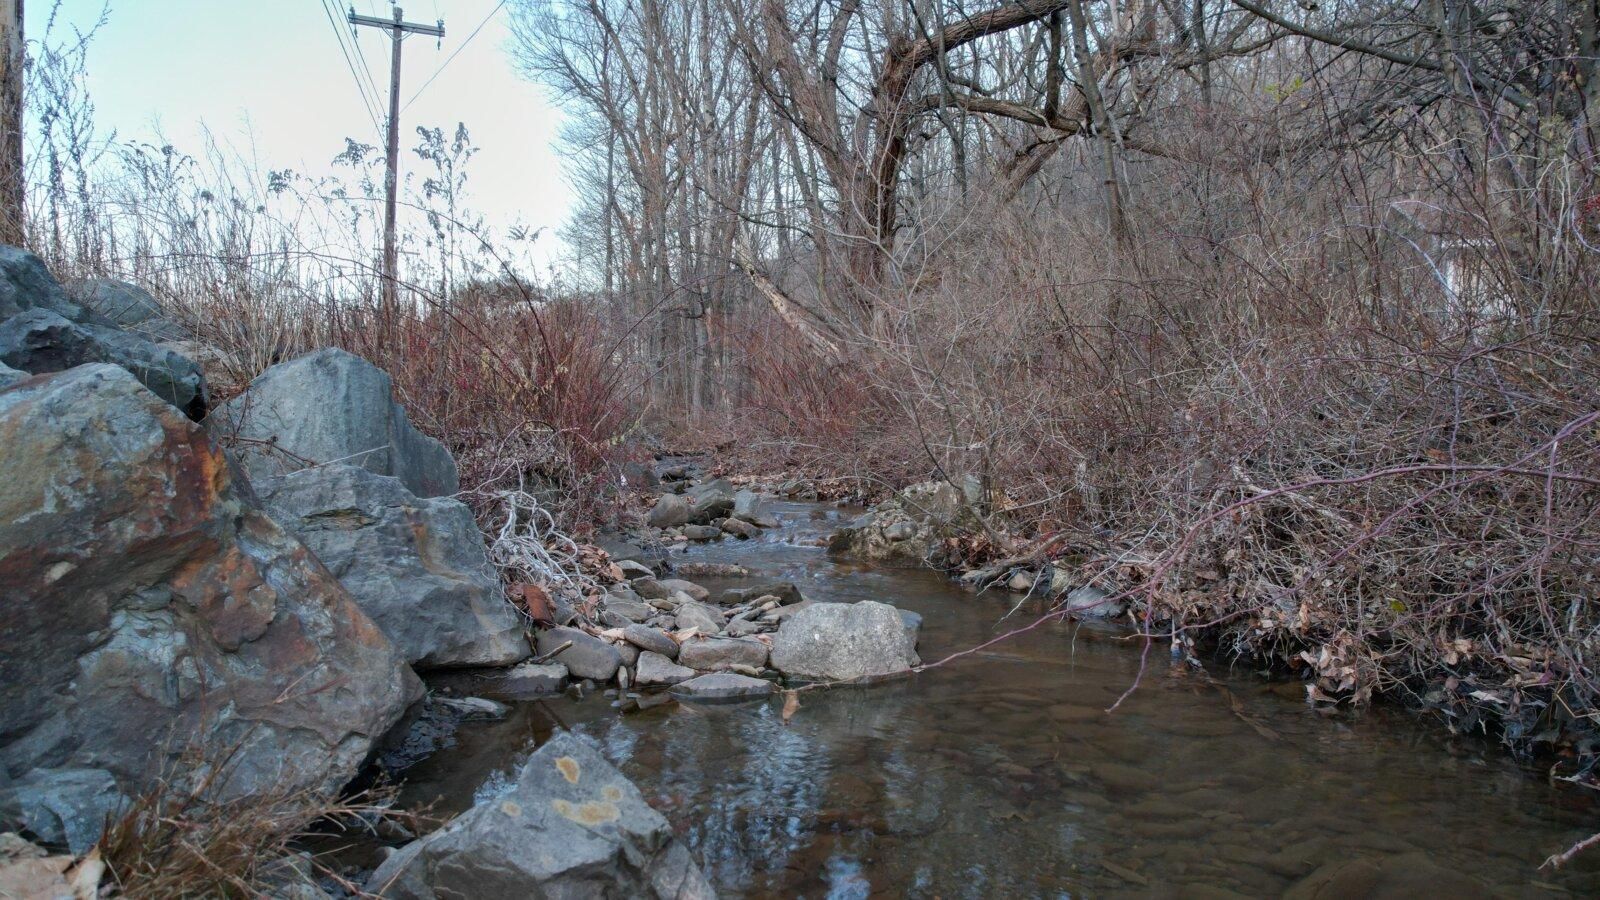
<box><xmin>366</xmin><ymin>732</ymin><xmax>715</xmax><ymax>900</ymax></box>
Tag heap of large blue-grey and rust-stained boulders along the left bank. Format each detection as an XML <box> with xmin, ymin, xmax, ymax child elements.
<box><xmin>0</xmin><ymin>247</ymin><xmax>713</xmax><ymax>898</ymax></box>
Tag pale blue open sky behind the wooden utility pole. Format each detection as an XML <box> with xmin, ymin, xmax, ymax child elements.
<box><xmin>26</xmin><ymin>0</ymin><xmax>570</xmax><ymax>259</ymax></box>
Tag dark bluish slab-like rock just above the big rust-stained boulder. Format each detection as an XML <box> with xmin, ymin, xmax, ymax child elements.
<box><xmin>0</xmin><ymin>309</ymin><xmax>206</xmax><ymax>421</ymax></box>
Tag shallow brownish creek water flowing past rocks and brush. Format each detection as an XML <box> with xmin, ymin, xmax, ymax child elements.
<box><xmin>403</xmin><ymin>503</ymin><xmax>1600</xmax><ymax>898</ymax></box>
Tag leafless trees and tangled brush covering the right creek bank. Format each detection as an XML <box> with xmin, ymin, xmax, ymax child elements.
<box><xmin>512</xmin><ymin>0</ymin><xmax>1600</xmax><ymax>737</ymax></box>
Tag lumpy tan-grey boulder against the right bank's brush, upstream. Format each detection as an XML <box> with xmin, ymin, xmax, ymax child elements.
<box><xmin>827</xmin><ymin>479</ymin><xmax>982</xmax><ymax>565</ymax></box>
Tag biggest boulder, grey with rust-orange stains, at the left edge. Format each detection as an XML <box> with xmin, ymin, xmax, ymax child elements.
<box><xmin>0</xmin><ymin>365</ymin><xmax>421</xmax><ymax>794</ymax></box>
